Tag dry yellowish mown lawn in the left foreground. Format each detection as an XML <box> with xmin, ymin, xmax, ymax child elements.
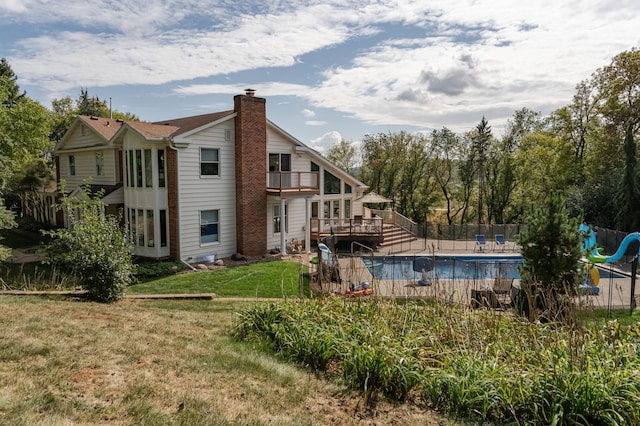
<box><xmin>0</xmin><ymin>296</ymin><xmax>449</xmax><ymax>426</ymax></box>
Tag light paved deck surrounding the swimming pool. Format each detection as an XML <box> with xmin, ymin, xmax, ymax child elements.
<box><xmin>336</xmin><ymin>236</ymin><xmax>640</xmax><ymax>309</ymax></box>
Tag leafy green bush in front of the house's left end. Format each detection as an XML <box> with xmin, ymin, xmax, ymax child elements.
<box><xmin>45</xmin><ymin>183</ymin><xmax>133</xmax><ymax>302</ymax></box>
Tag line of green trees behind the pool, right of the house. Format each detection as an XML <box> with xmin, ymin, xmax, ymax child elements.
<box><xmin>327</xmin><ymin>48</ymin><xmax>640</xmax><ymax>231</ymax></box>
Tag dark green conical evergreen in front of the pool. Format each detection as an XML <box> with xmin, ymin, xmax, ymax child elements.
<box><xmin>518</xmin><ymin>192</ymin><xmax>582</xmax><ymax>322</ymax></box>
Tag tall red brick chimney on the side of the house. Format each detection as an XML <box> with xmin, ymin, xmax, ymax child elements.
<box><xmin>233</xmin><ymin>89</ymin><xmax>267</xmax><ymax>256</ymax></box>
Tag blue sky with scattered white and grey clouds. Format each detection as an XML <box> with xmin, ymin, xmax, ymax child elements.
<box><xmin>0</xmin><ymin>0</ymin><xmax>640</xmax><ymax>153</ymax></box>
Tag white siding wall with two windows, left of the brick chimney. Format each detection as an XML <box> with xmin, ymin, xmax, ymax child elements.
<box><xmin>178</xmin><ymin>120</ymin><xmax>236</xmax><ymax>260</ymax></box>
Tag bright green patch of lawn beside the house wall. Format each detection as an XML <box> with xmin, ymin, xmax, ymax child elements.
<box><xmin>126</xmin><ymin>261</ymin><xmax>309</xmax><ymax>298</ymax></box>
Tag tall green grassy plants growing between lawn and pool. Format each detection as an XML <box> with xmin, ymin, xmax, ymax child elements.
<box><xmin>234</xmin><ymin>298</ymin><xmax>640</xmax><ymax>424</ymax></box>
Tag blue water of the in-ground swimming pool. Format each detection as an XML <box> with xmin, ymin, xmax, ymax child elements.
<box><xmin>362</xmin><ymin>256</ymin><xmax>623</xmax><ymax>280</ymax></box>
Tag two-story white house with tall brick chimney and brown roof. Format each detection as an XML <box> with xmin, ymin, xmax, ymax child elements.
<box><xmin>55</xmin><ymin>91</ymin><xmax>368</xmax><ymax>261</ymax></box>
